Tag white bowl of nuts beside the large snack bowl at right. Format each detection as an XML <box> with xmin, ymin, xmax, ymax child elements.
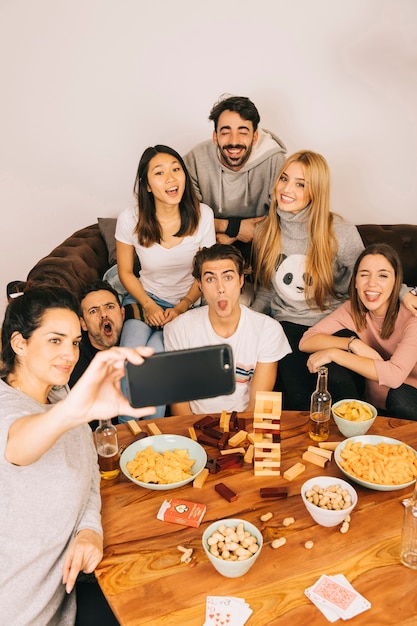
<box><xmin>301</xmin><ymin>476</ymin><xmax>358</xmax><ymax>526</ymax></box>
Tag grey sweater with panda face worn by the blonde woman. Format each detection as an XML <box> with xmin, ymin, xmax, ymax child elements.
<box><xmin>252</xmin><ymin>208</ymin><xmax>364</xmax><ymax>326</ymax></box>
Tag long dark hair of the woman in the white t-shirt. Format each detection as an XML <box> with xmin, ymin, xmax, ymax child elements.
<box><xmin>133</xmin><ymin>144</ymin><xmax>200</xmax><ymax>248</ymax></box>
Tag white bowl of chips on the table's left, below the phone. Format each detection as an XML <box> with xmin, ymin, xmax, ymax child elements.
<box><xmin>120</xmin><ymin>435</ymin><xmax>207</xmax><ymax>491</ymax></box>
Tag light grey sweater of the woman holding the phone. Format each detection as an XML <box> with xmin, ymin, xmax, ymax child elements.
<box><xmin>0</xmin><ymin>380</ymin><xmax>102</xmax><ymax>626</ymax></box>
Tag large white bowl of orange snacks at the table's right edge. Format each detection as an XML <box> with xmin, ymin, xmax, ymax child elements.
<box><xmin>334</xmin><ymin>435</ymin><xmax>417</xmax><ymax>491</ymax></box>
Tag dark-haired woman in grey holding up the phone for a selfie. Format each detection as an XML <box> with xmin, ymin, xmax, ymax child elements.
<box><xmin>0</xmin><ymin>287</ymin><xmax>152</xmax><ymax>626</ymax></box>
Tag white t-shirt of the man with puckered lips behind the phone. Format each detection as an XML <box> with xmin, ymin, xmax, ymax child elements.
<box><xmin>164</xmin><ymin>305</ymin><xmax>291</xmax><ymax>413</ymax></box>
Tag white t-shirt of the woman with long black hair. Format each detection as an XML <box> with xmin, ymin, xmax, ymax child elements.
<box><xmin>115</xmin><ymin>204</ymin><xmax>216</xmax><ymax>305</ymax></box>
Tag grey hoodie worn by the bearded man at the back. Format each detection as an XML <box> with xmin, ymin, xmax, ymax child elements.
<box><xmin>184</xmin><ymin>128</ymin><xmax>287</xmax><ymax>218</ymax></box>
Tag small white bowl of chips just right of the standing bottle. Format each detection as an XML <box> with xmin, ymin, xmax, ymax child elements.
<box><xmin>332</xmin><ymin>400</ymin><xmax>377</xmax><ymax>437</ymax></box>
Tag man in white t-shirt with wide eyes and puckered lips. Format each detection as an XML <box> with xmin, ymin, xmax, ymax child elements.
<box><xmin>164</xmin><ymin>243</ymin><xmax>291</xmax><ymax>415</ymax></box>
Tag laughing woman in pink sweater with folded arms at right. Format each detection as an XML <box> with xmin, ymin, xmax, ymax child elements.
<box><xmin>299</xmin><ymin>244</ymin><xmax>417</xmax><ymax>421</ymax></box>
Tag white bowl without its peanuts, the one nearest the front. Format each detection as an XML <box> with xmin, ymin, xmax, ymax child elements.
<box><xmin>202</xmin><ymin>518</ymin><xmax>263</xmax><ymax>578</ymax></box>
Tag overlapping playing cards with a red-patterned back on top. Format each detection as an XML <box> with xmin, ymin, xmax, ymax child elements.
<box><xmin>305</xmin><ymin>574</ymin><xmax>371</xmax><ymax>622</ymax></box>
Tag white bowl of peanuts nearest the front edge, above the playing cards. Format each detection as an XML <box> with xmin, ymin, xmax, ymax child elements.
<box><xmin>202</xmin><ymin>518</ymin><xmax>263</xmax><ymax>578</ymax></box>
